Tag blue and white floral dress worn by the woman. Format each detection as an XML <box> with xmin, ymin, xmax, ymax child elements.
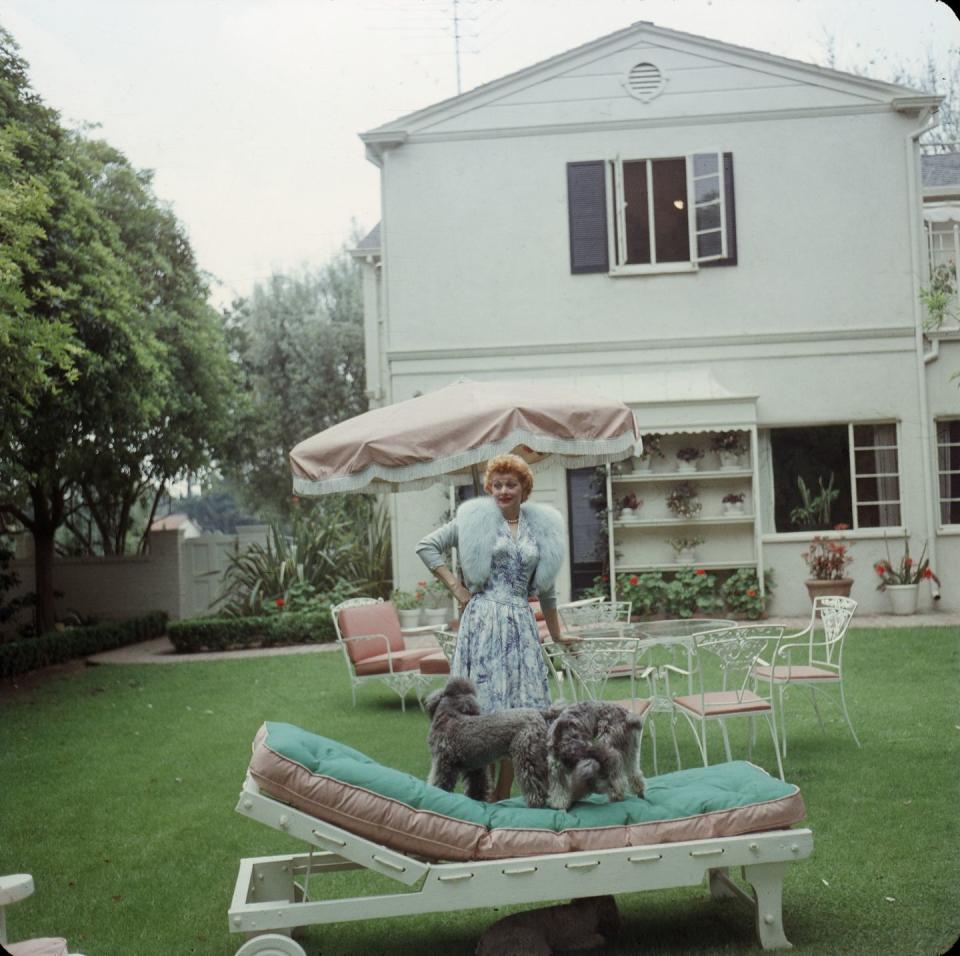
<box><xmin>450</xmin><ymin>517</ymin><xmax>550</xmax><ymax>713</ymax></box>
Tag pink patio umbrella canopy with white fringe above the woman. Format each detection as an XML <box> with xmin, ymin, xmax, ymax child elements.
<box><xmin>290</xmin><ymin>379</ymin><xmax>640</xmax><ymax>496</ymax></box>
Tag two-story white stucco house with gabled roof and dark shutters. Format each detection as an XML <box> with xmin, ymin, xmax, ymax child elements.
<box><xmin>354</xmin><ymin>22</ymin><xmax>960</xmax><ymax>614</ymax></box>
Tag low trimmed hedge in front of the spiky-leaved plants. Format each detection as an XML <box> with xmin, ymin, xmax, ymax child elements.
<box><xmin>167</xmin><ymin>610</ymin><xmax>336</xmax><ymax>654</ymax></box>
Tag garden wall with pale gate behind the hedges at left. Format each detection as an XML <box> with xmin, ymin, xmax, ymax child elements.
<box><xmin>10</xmin><ymin>525</ymin><xmax>268</xmax><ymax>624</ymax></box>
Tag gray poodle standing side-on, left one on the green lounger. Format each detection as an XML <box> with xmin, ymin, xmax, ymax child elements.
<box><xmin>426</xmin><ymin>677</ymin><xmax>559</xmax><ymax>807</ymax></box>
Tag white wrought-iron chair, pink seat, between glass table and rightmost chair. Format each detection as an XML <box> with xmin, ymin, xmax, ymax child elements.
<box><xmin>662</xmin><ymin>624</ymin><xmax>783</xmax><ymax>780</ymax></box>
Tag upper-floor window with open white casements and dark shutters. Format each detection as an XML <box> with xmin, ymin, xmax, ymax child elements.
<box><xmin>567</xmin><ymin>153</ymin><xmax>736</xmax><ymax>275</ymax></box>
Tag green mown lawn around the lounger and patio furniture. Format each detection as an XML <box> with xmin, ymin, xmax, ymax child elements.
<box><xmin>0</xmin><ymin>628</ymin><xmax>960</xmax><ymax>956</ymax></box>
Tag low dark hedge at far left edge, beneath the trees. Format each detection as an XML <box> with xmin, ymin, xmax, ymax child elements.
<box><xmin>0</xmin><ymin>611</ymin><xmax>167</xmax><ymax>678</ymax></box>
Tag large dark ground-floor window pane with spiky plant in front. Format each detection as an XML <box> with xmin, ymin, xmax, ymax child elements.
<box><xmin>770</xmin><ymin>425</ymin><xmax>853</xmax><ymax>531</ymax></box>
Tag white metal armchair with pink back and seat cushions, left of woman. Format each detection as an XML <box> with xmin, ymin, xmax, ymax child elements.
<box><xmin>330</xmin><ymin>597</ymin><xmax>435</xmax><ymax>711</ymax></box>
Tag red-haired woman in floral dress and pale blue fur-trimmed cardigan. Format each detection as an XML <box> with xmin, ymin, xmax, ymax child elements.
<box><xmin>417</xmin><ymin>455</ymin><xmax>565</xmax><ymax>800</ymax></box>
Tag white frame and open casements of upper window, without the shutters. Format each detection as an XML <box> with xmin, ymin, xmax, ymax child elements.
<box><xmin>605</xmin><ymin>149</ymin><xmax>729</xmax><ymax>275</ymax></box>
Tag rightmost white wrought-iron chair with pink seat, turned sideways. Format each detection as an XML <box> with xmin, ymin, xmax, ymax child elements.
<box><xmin>754</xmin><ymin>597</ymin><xmax>860</xmax><ymax>757</ymax></box>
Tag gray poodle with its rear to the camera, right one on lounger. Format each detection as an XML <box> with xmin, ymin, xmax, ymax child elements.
<box><xmin>547</xmin><ymin>700</ymin><xmax>644</xmax><ymax>810</ymax></box>
